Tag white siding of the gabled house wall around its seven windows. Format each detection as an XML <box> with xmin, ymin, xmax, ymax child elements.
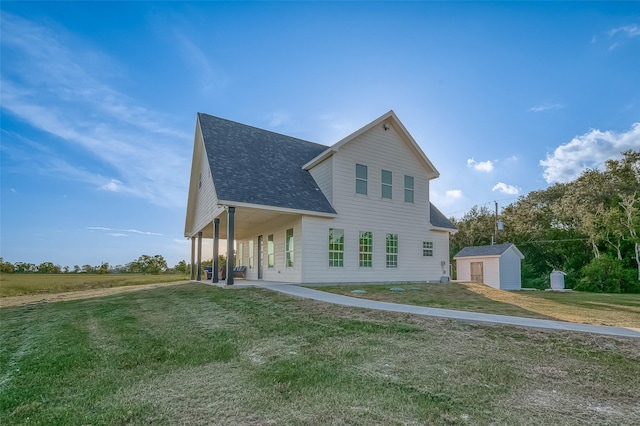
<box><xmin>302</xmin><ymin>125</ymin><xmax>449</xmax><ymax>282</ymax></box>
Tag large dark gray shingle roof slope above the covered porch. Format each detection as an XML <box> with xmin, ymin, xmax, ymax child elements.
<box><xmin>198</xmin><ymin>113</ymin><xmax>336</xmax><ymax>213</ymax></box>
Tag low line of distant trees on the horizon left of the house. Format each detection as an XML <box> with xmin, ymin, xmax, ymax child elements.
<box><xmin>0</xmin><ymin>254</ymin><xmax>191</xmax><ymax>274</ymax></box>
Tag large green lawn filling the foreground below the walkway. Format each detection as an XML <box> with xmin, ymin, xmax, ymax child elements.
<box><xmin>0</xmin><ymin>283</ymin><xmax>640</xmax><ymax>425</ymax></box>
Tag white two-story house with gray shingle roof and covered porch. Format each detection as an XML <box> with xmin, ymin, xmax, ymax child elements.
<box><xmin>185</xmin><ymin>111</ymin><xmax>456</xmax><ymax>284</ymax></box>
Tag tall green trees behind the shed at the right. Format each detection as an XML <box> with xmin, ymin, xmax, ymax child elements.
<box><xmin>450</xmin><ymin>150</ymin><xmax>640</xmax><ymax>293</ymax></box>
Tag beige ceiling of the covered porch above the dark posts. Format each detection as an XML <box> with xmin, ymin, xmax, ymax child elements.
<box><xmin>202</xmin><ymin>207</ymin><xmax>301</xmax><ymax>240</ymax></box>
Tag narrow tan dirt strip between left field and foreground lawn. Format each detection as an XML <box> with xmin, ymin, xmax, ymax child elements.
<box><xmin>0</xmin><ymin>281</ymin><xmax>191</xmax><ymax>308</ymax></box>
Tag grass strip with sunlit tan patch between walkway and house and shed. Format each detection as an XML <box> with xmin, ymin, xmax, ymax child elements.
<box><xmin>316</xmin><ymin>283</ymin><xmax>640</xmax><ymax>328</ymax></box>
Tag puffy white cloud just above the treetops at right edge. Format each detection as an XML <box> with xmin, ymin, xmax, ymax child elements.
<box><xmin>540</xmin><ymin>122</ymin><xmax>640</xmax><ymax>183</ymax></box>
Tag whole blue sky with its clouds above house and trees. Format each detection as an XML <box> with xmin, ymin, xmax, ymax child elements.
<box><xmin>0</xmin><ymin>1</ymin><xmax>640</xmax><ymax>266</ymax></box>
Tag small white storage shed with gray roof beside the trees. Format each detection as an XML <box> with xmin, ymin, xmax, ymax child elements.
<box><xmin>453</xmin><ymin>243</ymin><xmax>524</xmax><ymax>290</ymax></box>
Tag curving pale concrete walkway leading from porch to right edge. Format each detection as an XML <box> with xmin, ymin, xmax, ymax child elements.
<box><xmin>254</xmin><ymin>281</ymin><xmax>640</xmax><ymax>338</ymax></box>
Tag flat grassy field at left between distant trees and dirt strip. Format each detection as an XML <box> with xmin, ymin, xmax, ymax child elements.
<box><xmin>0</xmin><ymin>274</ymin><xmax>189</xmax><ymax>297</ymax></box>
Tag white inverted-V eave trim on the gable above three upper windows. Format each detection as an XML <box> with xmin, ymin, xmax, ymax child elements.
<box><xmin>303</xmin><ymin>110</ymin><xmax>440</xmax><ymax>179</ymax></box>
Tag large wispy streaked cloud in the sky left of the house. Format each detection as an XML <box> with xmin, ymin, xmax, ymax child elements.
<box><xmin>0</xmin><ymin>13</ymin><xmax>193</xmax><ymax>207</ymax></box>
